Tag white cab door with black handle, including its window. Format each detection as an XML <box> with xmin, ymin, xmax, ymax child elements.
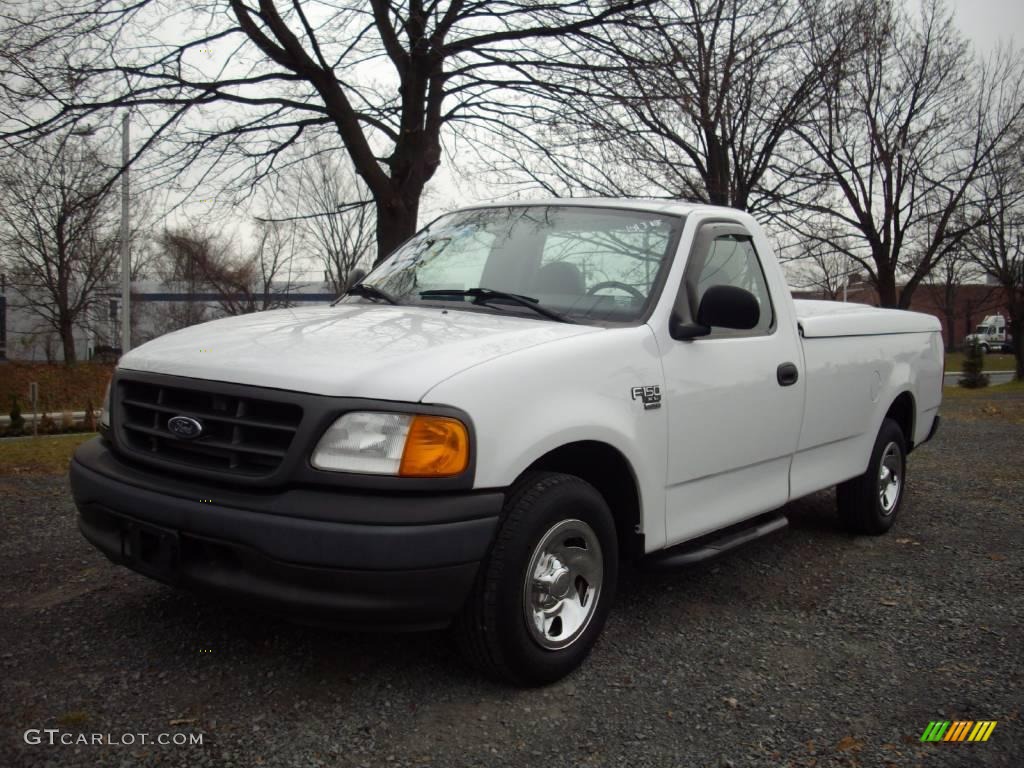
<box><xmin>663</xmin><ymin>222</ymin><xmax>804</xmax><ymax>545</ymax></box>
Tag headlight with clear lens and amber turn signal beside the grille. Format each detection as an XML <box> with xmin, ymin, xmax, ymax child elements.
<box><xmin>310</xmin><ymin>412</ymin><xmax>469</xmax><ymax>477</ymax></box>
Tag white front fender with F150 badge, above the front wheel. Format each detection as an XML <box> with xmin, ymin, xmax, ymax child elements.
<box><xmin>424</xmin><ymin>326</ymin><xmax>668</xmax><ymax>548</ymax></box>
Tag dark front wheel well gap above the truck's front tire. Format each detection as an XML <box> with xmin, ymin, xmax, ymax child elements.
<box><xmin>524</xmin><ymin>440</ymin><xmax>644</xmax><ymax>560</ymax></box>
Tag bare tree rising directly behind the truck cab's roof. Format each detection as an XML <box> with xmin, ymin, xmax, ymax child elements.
<box><xmin>475</xmin><ymin>0</ymin><xmax>857</xmax><ymax>212</ymax></box>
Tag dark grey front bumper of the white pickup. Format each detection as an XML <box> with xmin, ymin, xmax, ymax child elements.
<box><xmin>71</xmin><ymin>438</ymin><xmax>504</xmax><ymax>629</ymax></box>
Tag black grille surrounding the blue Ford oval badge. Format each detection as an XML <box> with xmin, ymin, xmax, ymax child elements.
<box><xmin>118</xmin><ymin>379</ymin><xmax>302</xmax><ymax>477</ymax></box>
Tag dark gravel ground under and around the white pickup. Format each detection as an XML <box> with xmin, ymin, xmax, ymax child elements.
<box><xmin>0</xmin><ymin>401</ymin><xmax>1024</xmax><ymax>768</ymax></box>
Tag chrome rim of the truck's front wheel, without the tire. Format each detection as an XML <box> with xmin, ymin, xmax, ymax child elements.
<box><xmin>522</xmin><ymin>520</ymin><xmax>604</xmax><ymax>650</ymax></box>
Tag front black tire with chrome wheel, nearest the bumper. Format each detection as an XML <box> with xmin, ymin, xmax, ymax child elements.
<box><xmin>455</xmin><ymin>472</ymin><xmax>618</xmax><ymax>686</ymax></box>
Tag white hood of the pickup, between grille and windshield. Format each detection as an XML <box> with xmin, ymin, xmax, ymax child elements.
<box><xmin>119</xmin><ymin>304</ymin><xmax>601</xmax><ymax>401</ymax></box>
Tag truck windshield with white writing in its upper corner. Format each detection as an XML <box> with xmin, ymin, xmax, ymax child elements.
<box><xmin>344</xmin><ymin>206</ymin><xmax>682</xmax><ymax>323</ymax></box>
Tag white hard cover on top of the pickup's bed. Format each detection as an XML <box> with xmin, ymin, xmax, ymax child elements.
<box><xmin>793</xmin><ymin>299</ymin><xmax>939</xmax><ymax>339</ymax></box>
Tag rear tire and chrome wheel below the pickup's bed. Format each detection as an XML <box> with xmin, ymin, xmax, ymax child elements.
<box><xmin>836</xmin><ymin>418</ymin><xmax>906</xmax><ymax>536</ymax></box>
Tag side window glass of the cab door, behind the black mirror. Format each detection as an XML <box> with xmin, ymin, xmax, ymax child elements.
<box><xmin>686</xmin><ymin>234</ymin><xmax>775</xmax><ymax>337</ymax></box>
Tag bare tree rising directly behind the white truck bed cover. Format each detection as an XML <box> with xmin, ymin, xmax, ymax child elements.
<box><xmin>790</xmin><ymin>0</ymin><xmax>1024</xmax><ymax>308</ymax></box>
